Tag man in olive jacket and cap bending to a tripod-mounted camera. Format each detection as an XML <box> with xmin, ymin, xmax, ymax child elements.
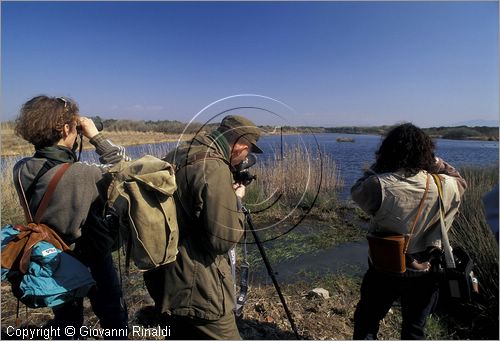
<box><xmin>144</xmin><ymin>116</ymin><xmax>262</xmax><ymax>339</ymax></box>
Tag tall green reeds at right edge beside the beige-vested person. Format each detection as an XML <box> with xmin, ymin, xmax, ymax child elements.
<box><xmin>450</xmin><ymin>166</ymin><xmax>499</xmax><ymax>339</ymax></box>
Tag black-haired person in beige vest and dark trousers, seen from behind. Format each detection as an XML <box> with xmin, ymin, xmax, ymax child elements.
<box><xmin>351</xmin><ymin>123</ymin><xmax>467</xmax><ymax>340</ymax></box>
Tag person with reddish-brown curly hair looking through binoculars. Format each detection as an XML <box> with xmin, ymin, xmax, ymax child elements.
<box><xmin>14</xmin><ymin>95</ymin><xmax>128</xmax><ymax>339</ymax></box>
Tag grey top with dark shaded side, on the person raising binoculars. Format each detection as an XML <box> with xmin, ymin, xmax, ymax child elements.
<box><xmin>14</xmin><ymin>134</ymin><xmax>130</xmax><ymax>261</ymax></box>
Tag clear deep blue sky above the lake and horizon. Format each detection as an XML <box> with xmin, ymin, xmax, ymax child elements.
<box><xmin>1</xmin><ymin>1</ymin><xmax>499</xmax><ymax>127</ymax></box>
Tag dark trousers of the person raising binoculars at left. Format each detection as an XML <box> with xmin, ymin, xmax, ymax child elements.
<box><xmin>53</xmin><ymin>254</ymin><xmax>128</xmax><ymax>339</ymax></box>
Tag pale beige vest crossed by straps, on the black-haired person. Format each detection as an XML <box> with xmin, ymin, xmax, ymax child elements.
<box><xmin>370</xmin><ymin>171</ymin><xmax>460</xmax><ymax>254</ymax></box>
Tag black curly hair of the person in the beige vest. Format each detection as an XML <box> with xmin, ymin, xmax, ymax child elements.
<box><xmin>373</xmin><ymin>123</ymin><xmax>435</xmax><ymax>176</ymax></box>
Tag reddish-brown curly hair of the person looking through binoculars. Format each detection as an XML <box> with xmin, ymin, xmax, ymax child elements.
<box><xmin>15</xmin><ymin>95</ymin><xmax>79</xmax><ymax>149</ymax></box>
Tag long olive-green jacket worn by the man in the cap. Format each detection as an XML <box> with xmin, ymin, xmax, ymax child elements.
<box><xmin>144</xmin><ymin>131</ymin><xmax>244</xmax><ymax>320</ymax></box>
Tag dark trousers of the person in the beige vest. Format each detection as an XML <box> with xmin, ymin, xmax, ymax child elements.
<box><xmin>353</xmin><ymin>268</ymin><xmax>439</xmax><ymax>340</ymax></box>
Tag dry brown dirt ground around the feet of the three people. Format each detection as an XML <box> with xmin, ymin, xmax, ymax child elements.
<box><xmin>1</xmin><ymin>272</ymin><xmax>418</xmax><ymax>340</ymax></box>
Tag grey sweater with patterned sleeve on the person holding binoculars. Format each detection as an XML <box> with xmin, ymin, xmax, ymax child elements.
<box><xmin>14</xmin><ymin>134</ymin><xmax>127</xmax><ymax>250</ymax></box>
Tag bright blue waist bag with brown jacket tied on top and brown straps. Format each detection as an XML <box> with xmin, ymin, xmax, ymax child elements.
<box><xmin>0</xmin><ymin>163</ymin><xmax>95</xmax><ymax>308</ymax></box>
